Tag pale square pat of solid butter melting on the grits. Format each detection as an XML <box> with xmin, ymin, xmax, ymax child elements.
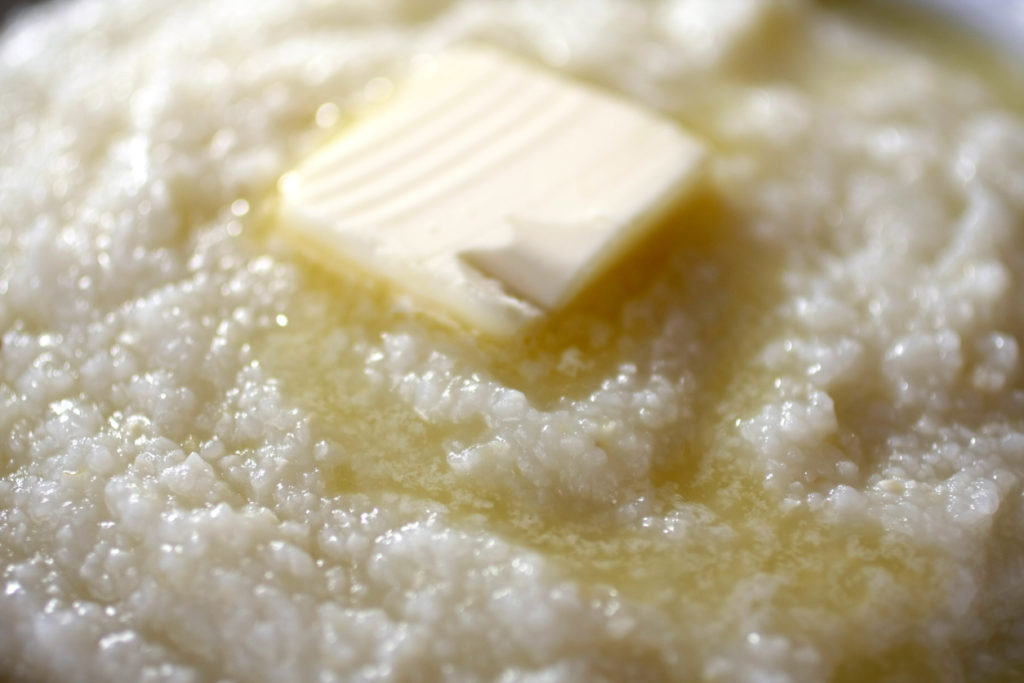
<box><xmin>279</xmin><ymin>48</ymin><xmax>703</xmax><ymax>334</ymax></box>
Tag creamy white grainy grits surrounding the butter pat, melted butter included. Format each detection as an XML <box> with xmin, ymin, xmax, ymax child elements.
<box><xmin>0</xmin><ymin>0</ymin><xmax>1024</xmax><ymax>683</ymax></box>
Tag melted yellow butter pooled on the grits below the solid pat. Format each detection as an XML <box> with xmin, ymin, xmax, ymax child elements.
<box><xmin>255</xmin><ymin>188</ymin><xmax>947</xmax><ymax>680</ymax></box>
